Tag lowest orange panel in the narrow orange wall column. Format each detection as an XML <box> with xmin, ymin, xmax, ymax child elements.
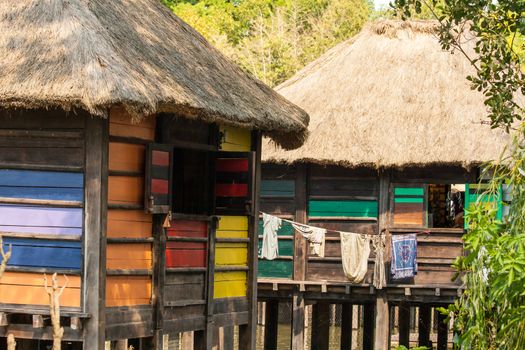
<box><xmin>106</xmin><ymin>276</ymin><xmax>151</xmax><ymax>307</ymax></box>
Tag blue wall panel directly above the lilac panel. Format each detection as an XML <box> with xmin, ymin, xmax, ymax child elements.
<box><xmin>0</xmin><ymin>169</ymin><xmax>84</xmax><ymax>201</ymax></box>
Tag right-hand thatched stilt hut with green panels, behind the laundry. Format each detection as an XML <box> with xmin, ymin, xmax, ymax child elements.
<box><xmin>258</xmin><ymin>21</ymin><xmax>507</xmax><ymax>350</ymax></box>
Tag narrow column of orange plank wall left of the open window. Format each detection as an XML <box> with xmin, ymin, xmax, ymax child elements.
<box><xmin>106</xmin><ymin>108</ymin><xmax>155</xmax><ymax>307</ymax></box>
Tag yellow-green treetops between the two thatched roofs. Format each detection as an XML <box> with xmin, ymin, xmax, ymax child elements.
<box><xmin>163</xmin><ymin>0</ymin><xmax>372</xmax><ymax>86</ymax></box>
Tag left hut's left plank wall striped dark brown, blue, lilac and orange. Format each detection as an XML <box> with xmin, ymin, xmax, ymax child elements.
<box><xmin>0</xmin><ymin>109</ymin><xmax>87</xmax><ymax>311</ymax></box>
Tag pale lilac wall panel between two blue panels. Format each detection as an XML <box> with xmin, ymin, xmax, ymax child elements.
<box><xmin>0</xmin><ymin>205</ymin><xmax>83</xmax><ymax>235</ymax></box>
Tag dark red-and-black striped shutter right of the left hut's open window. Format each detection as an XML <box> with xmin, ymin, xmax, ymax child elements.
<box><xmin>215</xmin><ymin>152</ymin><xmax>255</xmax><ymax>215</ymax></box>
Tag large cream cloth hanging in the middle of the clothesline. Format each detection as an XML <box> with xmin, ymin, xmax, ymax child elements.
<box><xmin>339</xmin><ymin>232</ymin><xmax>370</xmax><ymax>283</ymax></box>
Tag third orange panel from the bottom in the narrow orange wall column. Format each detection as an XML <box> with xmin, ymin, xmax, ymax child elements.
<box><xmin>107</xmin><ymin>209</ymin><xmax>152</xmax><ymax>238</ymax></box>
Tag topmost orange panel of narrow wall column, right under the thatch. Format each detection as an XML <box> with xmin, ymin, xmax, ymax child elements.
<box><xmin>109</xmin><ymin>107</ymin><xmax>155</xmax><ymax>141</ymax></box>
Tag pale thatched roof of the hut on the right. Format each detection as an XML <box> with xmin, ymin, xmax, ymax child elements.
<box><xmin>263</xmin><ymin>21</ymin><xmax>508</xmax><ymax>167</ymax></box>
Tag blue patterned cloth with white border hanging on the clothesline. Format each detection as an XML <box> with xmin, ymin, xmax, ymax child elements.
<box><xmin>391</xmin><ymin>233</ymin><xmax>417</xmax><ymax>279</ymax></box>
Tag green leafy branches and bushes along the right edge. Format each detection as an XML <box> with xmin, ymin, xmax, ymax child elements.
<box><xmin>392</xmin><ymin>0</ymin><xmax>525</xmax><ymax>349</ymax></box>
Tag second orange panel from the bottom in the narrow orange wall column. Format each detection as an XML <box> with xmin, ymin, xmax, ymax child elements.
<box><xmin>106</xmin><ymin>243</ymin><xmax>152</xmax><ymax>270</ymax></box>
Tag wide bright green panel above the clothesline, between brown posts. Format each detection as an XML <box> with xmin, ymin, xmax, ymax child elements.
<box><xmin>308</xmin><ymin>201</ymin><xmax>378</xmax><ymax>217</ymax></box>
